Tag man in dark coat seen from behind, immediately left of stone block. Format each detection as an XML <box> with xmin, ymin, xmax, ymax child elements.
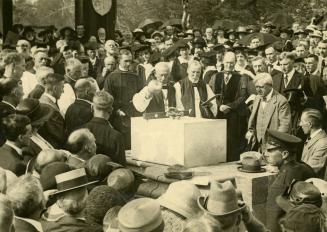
<box><xmin>85</xmin><ymin>91</ymin><xmax>126</xmax><ymax>165</ymax></box>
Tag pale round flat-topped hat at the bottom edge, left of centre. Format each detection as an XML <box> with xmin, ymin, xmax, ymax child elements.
<box><xmin>118</xmin><ymin>198</ymin><xmax>164</xmax><ymax>232</ymax></box>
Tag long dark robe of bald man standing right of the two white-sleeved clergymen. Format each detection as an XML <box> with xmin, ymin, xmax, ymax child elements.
<box><xmin>209</xmin><ymin>72</ymin><xmax>248</xmax><ymax>161</ymax></box>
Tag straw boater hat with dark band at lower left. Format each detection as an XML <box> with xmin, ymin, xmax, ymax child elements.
<box><xmin>51</xmin><ymin>168</ymin><xmax>99</xmax><ymax>195</ymax></box>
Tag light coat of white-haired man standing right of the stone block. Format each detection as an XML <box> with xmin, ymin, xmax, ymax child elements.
<box><xmin>248</xmin><ymin>90</ymin><xmax>291</xmax><ymax>146</ymax></box>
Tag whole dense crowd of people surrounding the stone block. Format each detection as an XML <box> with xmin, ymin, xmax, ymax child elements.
<box><xmin>0</xmin><ymin>9</ymin><xmax>327</xmax><ymax>232</ymax></box>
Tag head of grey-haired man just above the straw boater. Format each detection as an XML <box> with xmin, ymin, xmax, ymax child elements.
<box><xmin>67</xmin><ymin>128</ymin><xmax>97</xmax><ymax>168</ymax></box>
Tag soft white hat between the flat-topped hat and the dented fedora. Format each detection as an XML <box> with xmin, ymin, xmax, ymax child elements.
<box><xmin>158</xmin><ymin>181</ymin><xmax>201</xmax><ymax>218</ymax></box>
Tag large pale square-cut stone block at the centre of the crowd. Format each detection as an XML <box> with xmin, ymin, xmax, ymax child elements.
<box><xmin>131</xmin><ymin>117</ymin><xmax>226</xmax><ymax>167</ymax></box>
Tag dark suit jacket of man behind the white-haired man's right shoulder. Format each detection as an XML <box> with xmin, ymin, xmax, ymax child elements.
<box><xmin>272</xmin><ymin>71</ymin><xmax>312</xmax><ymax>96</ymax></box>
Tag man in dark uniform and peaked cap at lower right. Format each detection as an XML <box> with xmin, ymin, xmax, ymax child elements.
<box><xmin>265</xmin><ymin>130</ymin><xmax>316</xmax><ymax>232</ymax></box>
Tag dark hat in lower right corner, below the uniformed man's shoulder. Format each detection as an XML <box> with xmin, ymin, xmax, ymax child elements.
<box><xmin>276</xmin><ymin>180</ymin><xmax>322</xmax><ymax>212</ymax></box>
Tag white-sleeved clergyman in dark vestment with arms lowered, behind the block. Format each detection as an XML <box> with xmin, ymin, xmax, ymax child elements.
<box><xmin>174</xmin><ymin>60</ymin><xmax>217</xmax><ymax>118</ymax></box>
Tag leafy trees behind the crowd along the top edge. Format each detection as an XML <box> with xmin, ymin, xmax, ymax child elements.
<box><xmin>14</xmin><ymin>0</ymin><xmax>327</xmax><ymax>30</ymax></box>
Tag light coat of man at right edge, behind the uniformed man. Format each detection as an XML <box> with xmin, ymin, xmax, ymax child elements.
<box><xmin>301</xmin><ymin>131</ymin><xmax>327</xmax><ymax>178</ymax></box>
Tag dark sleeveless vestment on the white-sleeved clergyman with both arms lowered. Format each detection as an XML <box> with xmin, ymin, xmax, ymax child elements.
<box><xmin>179</xmin><ymin>78</ymin><xmax>208</xmax><ymax>117</ymax></box>
